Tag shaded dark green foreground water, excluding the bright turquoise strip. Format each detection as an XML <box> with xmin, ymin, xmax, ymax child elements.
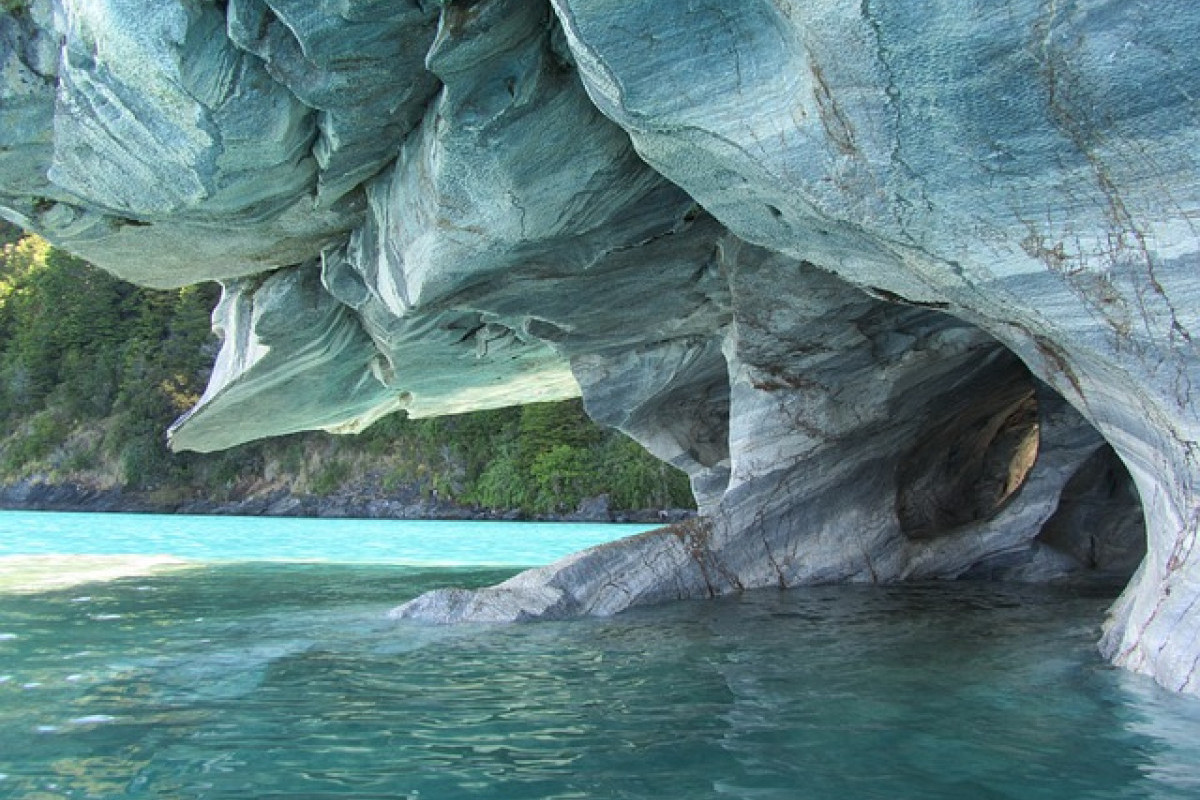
<box><xmin>0</xmin><ymin>516</ymin><xmax>1200</xmax><ymax>800</ymax></box>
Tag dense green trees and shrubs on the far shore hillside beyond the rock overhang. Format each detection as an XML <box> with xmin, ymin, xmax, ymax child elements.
<box><xmin>0</xmin><ymin>223</ymin><xmax>690</xmax><ymax>513</ymax></box>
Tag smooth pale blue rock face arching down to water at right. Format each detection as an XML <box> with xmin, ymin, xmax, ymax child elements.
<box><xmin>554</xmin><ymin>0</ymin><xmax>1200</xmax><ymax>690</ymax></box>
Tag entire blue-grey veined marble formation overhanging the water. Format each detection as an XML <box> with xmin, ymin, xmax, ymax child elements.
<box><xmin>0</xmin><ymin>0</ymin><xmax>1200</xmax><ymax>691</ymax></box>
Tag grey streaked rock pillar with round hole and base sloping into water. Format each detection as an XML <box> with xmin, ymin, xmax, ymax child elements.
<box><xmin>397</xmin><ymin>256</ymin><xmax>1123</xmax><ymax>620</ymax></box>
